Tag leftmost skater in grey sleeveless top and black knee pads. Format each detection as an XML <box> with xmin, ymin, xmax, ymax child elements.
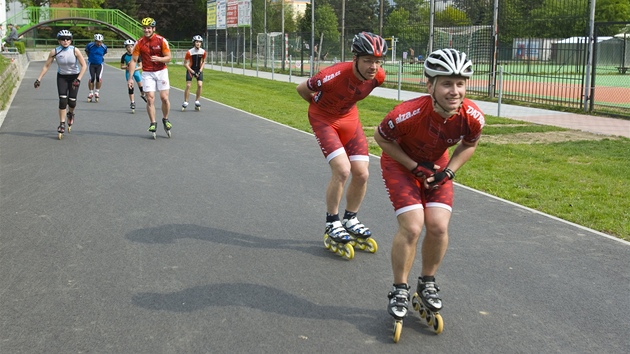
<box><xmin>34</xmin><ymin>30</ymin><xmax>87</xmax><ymax>140</ymax></box>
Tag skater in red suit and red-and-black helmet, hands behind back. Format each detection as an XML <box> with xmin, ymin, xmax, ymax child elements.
<box><xmin>297</xmin><ymin>32</ymin><xmax>387</xmax><ymax>259</ymax></box>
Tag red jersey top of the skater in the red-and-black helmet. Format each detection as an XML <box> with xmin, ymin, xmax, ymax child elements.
<box><xmin>306</xmin><ymin>62</ymin><xmax>385</xmax><ymax>121</ymax></box>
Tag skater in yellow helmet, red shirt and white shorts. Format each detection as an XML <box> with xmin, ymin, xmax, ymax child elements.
<box><xmin>127</xmin><ymin>17</ymin><xmax>173</xmax><ymax>139</ymax></box>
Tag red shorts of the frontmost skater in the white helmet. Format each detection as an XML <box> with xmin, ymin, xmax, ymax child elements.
<box><xmin>381</xmin><ymin>154</ymin><xmax>453</xmax><ymax>216</ymax></box>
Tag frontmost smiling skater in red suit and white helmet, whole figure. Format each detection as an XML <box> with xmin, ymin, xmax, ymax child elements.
<box><xmin>374</xmin><ymin>49</ymin><xmax>485</xmax><ymax>341</ymax></box>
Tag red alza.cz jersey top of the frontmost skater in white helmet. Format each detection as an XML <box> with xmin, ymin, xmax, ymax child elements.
<box><xmin>378</xmin><ymin>95</ymin><xmax>485</xmax><ymax>162</ymax></box>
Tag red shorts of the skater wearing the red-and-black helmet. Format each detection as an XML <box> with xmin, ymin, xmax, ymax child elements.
<box><xmin>308</xmin><ymin>111</ymin><xmax>369</xmax><ymax>162</ymax></box>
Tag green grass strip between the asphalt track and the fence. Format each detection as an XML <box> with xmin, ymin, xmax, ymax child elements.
<box><xmin>131</xmin><ymin>65</ymin><xmax>630</xmax><ymax>241</ymax></box>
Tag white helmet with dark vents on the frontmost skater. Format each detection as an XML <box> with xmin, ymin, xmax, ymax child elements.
<box><xmin>424</xmin><ymin>48</ymin><xmax>473</xmax><ymax>78</ymax></box>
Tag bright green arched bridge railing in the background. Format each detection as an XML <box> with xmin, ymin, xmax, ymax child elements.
<box><xmin>6</xmin><ymin>6</ymin><xmax>143</xmax><ymax>39</ymax></box>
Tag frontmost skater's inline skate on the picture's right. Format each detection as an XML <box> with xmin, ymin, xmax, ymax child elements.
<box><xmin>411</xmin><ymin>277</ymin><xmax>444</xmax><ymax>334</ymax></box>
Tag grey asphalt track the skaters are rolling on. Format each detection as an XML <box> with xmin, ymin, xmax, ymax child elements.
<box><xmin>0</xmin><ymin>62</ymin><xmax>630</xmax><ymax>353</ymax></box>
